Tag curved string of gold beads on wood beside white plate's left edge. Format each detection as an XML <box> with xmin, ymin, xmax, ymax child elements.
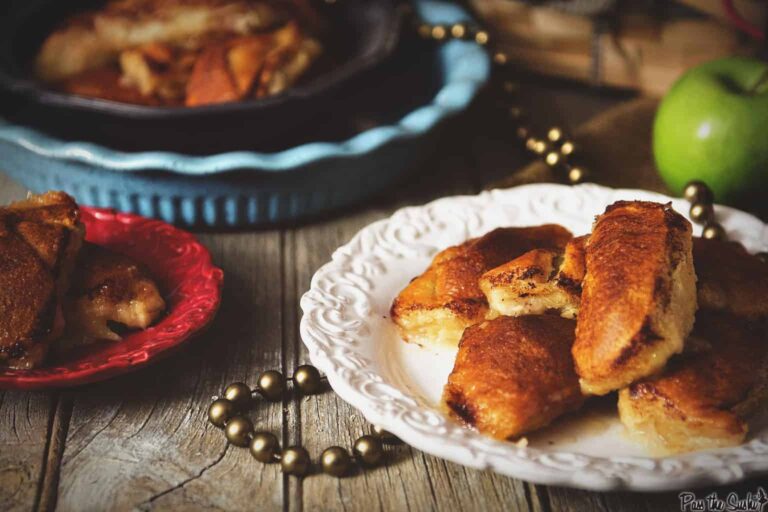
<box><xmin>208</xmin><ymin>365</ymin><xmax>399</xmax><ymax>477</ymax></box>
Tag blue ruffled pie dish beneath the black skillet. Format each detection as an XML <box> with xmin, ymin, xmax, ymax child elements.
<box><xmin>0</xmin><ymin>0</ymin><xmax>490</xmax><ymax>227</ymax></box>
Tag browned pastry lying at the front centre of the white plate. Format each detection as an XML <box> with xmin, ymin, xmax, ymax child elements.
<box><xmin>443</xmin><ymin>315</ymin><xmax>584</xmax><ymax>439</ymax></box>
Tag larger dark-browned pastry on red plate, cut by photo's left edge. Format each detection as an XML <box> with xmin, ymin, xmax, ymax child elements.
<box><xmin>0</xmin><ymin>192</ymin><xmax>83</xmax><ymax>368</ymax></box>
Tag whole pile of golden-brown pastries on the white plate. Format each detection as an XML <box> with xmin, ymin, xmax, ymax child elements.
<box><xmin>391</xmin><ymin>201</ymin><xmax>768</xmax><ymax>452</ymax></box>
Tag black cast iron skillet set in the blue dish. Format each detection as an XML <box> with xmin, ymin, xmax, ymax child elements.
<box><xmin>0</xmin><ymin>0</ymin><xmax>401</xmax><ymax>154</ymax></box>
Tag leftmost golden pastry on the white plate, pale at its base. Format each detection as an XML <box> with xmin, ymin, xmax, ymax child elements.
<box><xmin>390</xmin><ymin>224</ymin><xmax>571</xmax><ymax>346</ymax></box>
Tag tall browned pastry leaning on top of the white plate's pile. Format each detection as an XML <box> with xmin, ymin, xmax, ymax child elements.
<box><xmin>573</xmin><ymin>201</ymin><xmax>696</xmax><ymax>394</ymax></box>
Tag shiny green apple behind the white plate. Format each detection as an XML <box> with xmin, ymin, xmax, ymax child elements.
<box><xmin>653</xmin><ymin>57</ymin><xmax>768</xmax><ymax>203</ymax></box>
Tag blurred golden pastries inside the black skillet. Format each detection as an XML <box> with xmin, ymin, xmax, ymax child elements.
<box><xmin>35</xmin><ymin>0</ymin><xmax>321</xmax><ymax>107</ymax></box>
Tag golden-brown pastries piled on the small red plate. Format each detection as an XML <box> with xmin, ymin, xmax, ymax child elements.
<box><xmin>0</xmin><ymin>192</ymin><xmax>165</xmax><ymax>369</ymax></box>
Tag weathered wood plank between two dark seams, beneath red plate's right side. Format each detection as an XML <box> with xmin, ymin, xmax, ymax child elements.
<box><xmin>58</xmin><ymin>232</ymin><xmax>283</xmax><ymax>511</ymax></box>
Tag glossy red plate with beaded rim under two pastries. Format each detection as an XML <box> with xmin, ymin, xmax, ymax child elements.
<box><xmin>0</xmin><ymin>207</ymin><xmax>224</xmax><ymax>389</ymax></box>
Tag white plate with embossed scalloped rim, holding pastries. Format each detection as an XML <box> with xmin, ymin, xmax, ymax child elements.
<box><xmin>301</xmin><ymin>184</ymin><xmax>768</xmax><ymax>491</ymax></box>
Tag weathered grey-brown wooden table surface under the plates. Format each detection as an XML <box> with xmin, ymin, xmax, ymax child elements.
<box><xmin>0</xmin><ymin>85</ymin><xmax>761</xmax><ymax>512</ymax></box>
